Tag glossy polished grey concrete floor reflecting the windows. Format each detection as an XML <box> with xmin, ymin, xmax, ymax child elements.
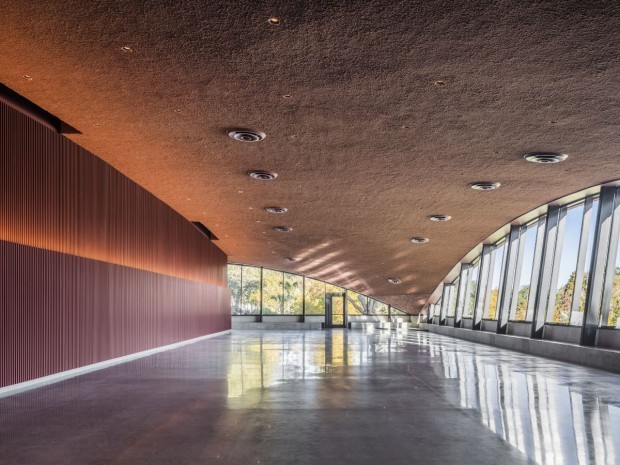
<box><xmin>0</xmin><ymin>330</ymin><xmax>620</xmax><ymax>465</ymax></box>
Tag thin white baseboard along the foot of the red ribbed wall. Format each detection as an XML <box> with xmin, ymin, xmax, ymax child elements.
<box><xmin>0</xmin><ymin>329</ymin><xmax>230</xmax><ymax>398</ymax></box>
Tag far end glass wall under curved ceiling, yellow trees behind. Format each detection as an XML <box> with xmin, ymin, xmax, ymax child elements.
<box><xmin>228</xmin><ymin>264</ymin><xmax>408</xmax><ymax>316</ymax></box>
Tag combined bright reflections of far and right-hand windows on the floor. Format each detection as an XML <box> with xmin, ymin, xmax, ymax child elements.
<box><xmin>227</xmin><ymin>330</ymin><xmax>620</xmax><ymax>465</ymax></box>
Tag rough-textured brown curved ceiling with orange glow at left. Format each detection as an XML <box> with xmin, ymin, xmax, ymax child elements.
<box><xmin>0</xmin><ymin>0</ymin><xmax>620</xmax><ymax>309</ymax></box>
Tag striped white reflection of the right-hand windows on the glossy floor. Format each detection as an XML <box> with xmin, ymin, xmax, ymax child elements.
<box><xmin>428</xmin><ymin>335</ymin><xmax>620</xmax><ymax>465</ymax></box>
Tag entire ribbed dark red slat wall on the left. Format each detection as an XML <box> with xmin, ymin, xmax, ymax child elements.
<box><xmin>0</xmin><ymin>103</ymin><xmax>230</xmax><ymax>387</ymax></box>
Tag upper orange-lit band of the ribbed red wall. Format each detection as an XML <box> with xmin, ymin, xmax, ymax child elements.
<box><xmin>0</xmin><ymin>102</ymin><xmax>226</xmax><ymax>286</ymax></box>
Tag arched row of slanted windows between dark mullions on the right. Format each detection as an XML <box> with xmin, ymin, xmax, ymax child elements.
<box><xmin>429</xmin><ymin>187</ymin><xmax>620</xmax><ymax>338</ymax></box>
